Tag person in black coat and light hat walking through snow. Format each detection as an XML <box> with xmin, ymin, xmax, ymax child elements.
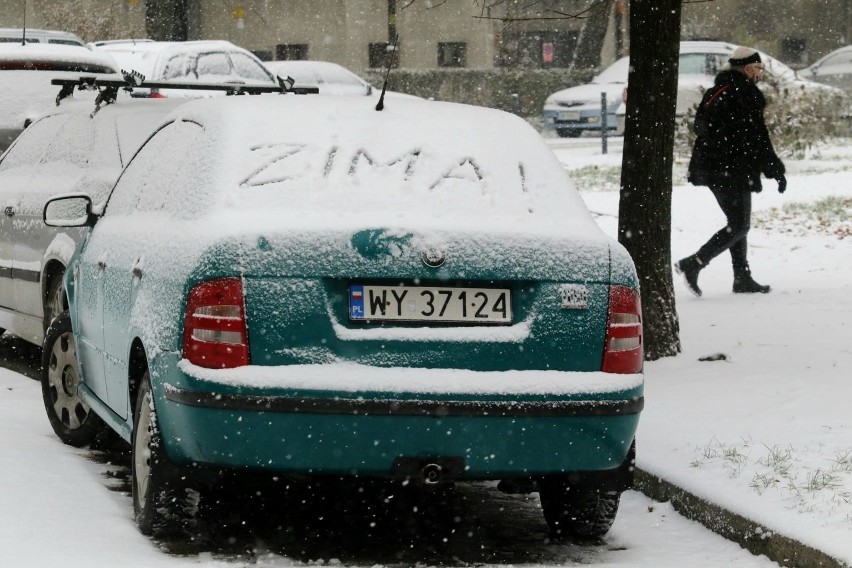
<box><xmin>674</xmin><ymin>47</ymin><xmax>787</xmax><ymax>296</ymax></box>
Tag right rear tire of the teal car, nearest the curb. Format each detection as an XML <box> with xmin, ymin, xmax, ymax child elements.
<box><xmin>539</xmin><ymin>481</ymin><xmax>621</xmax><ymax>538</ymax></box>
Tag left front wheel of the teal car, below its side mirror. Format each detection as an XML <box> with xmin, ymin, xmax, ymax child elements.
<box><xmin>41</xmin><ymin>313</ymin><xmax>105</xmax><ymax>447</ymax></box>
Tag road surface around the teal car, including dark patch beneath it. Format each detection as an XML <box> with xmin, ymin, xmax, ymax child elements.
<box><xmin>0</xmin><ymin>336</ymin><xmax>774</xmax><ymax>568</ymax></box>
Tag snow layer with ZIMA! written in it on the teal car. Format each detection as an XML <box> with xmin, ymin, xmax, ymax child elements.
<box><xmin>160</xmin><ymin>95</ymin><xmax>599</xmax><ymax>237</ymax></box>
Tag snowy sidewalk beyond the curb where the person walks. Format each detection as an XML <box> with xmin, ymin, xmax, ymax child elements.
<box><xmin>555</xmin><ymin>138</ymin><xmax>852</xmax><ymax>566</ymax></box>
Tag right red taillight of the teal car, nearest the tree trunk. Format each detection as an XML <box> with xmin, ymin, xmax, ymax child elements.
<box><xmin>601</xmin><ymin>286</ymin><xmax>644</xmax><ymax>373</ymax></box>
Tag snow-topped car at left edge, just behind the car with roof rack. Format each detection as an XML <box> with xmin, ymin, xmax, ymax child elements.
<box><xmin>0</xmin><ymin>43</ymin><xmax>118</xmax><ymax>152</ymax></box>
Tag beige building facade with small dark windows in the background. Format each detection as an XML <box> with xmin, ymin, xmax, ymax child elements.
<box><xmin>5</xmin><ymin>0</ymin><xmax>852</xmax><ymax>71</ymax></box>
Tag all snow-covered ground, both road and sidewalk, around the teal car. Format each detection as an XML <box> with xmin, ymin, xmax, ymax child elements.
<box><xmin>0</xmin><ymin>131</ymin><xmax>852</xmax><ymax>568</ymax></box>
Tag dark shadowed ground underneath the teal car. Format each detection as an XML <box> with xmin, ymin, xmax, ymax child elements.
<box><xmin>83</xmin><ymin>438</ymin><xmax>610</xmax><ymax>566</ymax></box>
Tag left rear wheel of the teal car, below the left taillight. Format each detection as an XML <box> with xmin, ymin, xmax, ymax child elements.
<box><xmin>131</xmin><ymin>370</ymin><xmax>198</xmax><ymax>535</ymax></box>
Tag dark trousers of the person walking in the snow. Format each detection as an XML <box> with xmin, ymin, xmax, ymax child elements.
<box><xmin>695</xmin><ymin>186</ymin><xmax>751</xmax><ymax>279</ymax></box>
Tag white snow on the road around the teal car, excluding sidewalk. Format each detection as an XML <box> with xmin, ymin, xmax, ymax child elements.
<box><xmin>0</xmin><ymin>360</ymin><xmax>774</xmax><ymax>568</ymax></box>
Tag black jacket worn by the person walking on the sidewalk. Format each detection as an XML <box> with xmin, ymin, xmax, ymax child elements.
<box><xmin>687</xmin><ymin>70</ymin><xmax>785</xmax><ymax>191</ymax></box>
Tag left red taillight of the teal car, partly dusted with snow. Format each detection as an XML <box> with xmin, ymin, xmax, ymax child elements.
<box><xmin>183</xmin><ymin>278</ymin><xmax>249</xmax><ymax>369</ymax></box>
